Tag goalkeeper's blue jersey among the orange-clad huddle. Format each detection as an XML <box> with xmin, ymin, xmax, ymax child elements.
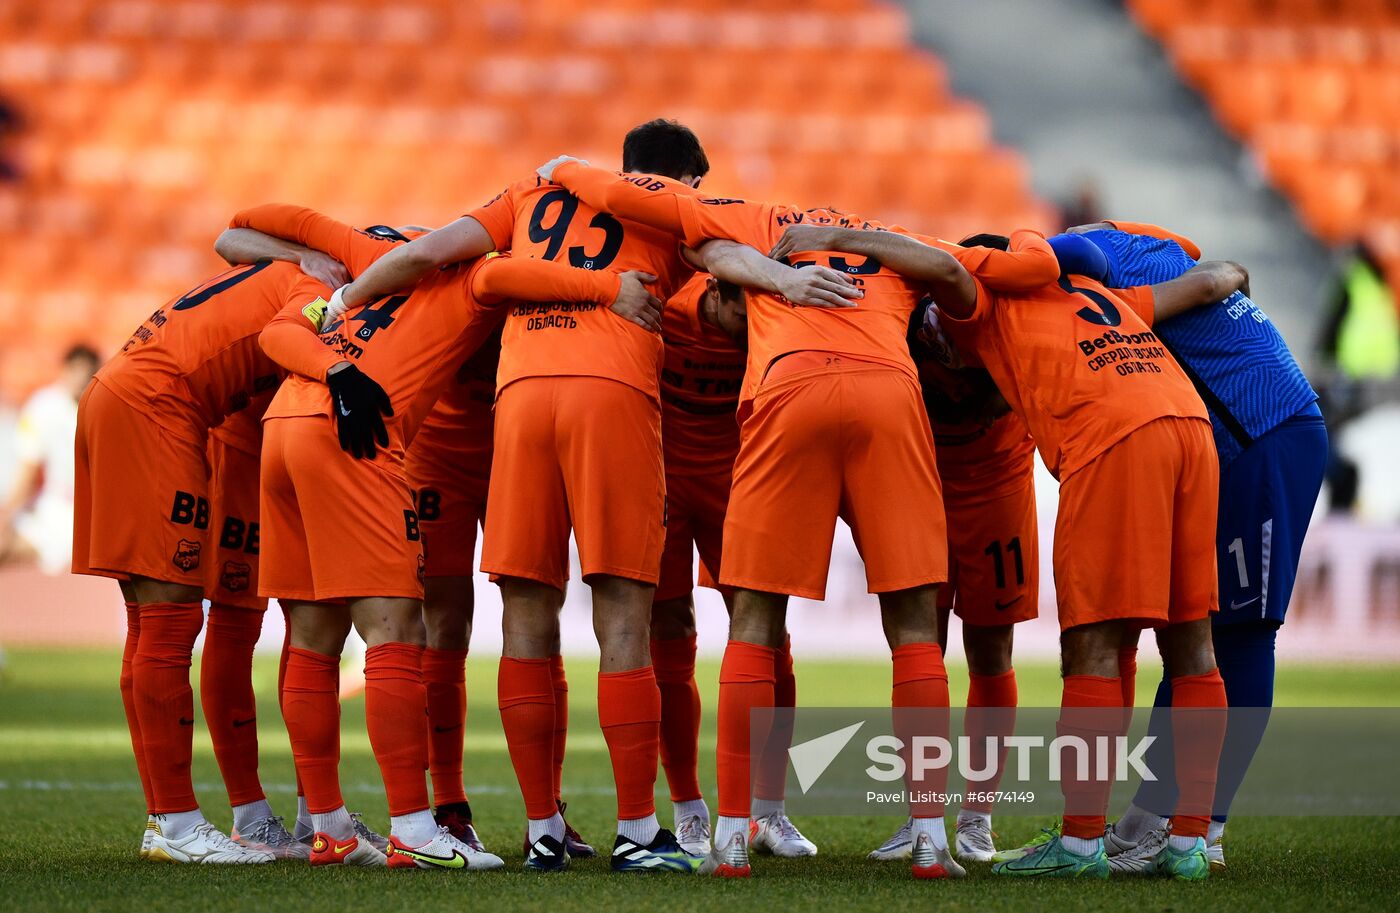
<box><xmin>1051</xmin><ymin>230</ymin><xmax>1317</xmax><ymax>466</ymax></box>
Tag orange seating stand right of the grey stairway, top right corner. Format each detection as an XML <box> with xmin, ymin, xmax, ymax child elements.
<box><xmin>1128</xmin><ymin>0</ymin><xmax>1400</xmax><ymax>284</ymax></box>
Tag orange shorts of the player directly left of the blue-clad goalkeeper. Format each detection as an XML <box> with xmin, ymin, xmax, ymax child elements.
<box><xmin>1054</xmin><ymin>417</ymin><xmax>1219</xmax><ymax>630</ymax></box>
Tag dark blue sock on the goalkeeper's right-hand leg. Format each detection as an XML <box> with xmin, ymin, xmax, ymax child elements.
<box><xmin>1214</xmin><ymin>620</ymin><xmax>1278</xmax><ymax>822</ymax></box>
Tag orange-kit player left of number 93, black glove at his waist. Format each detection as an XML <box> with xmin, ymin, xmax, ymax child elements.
<box><xmin>246</xmin><ymin>200</ymin><xmax>654</xmax><ymax>870</ymax></box>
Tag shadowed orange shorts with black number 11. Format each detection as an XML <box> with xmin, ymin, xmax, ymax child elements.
<box><xmin>938</xmin><ymin>473</ymin><xmax>1040</xmax><ymax>625</ymax></box>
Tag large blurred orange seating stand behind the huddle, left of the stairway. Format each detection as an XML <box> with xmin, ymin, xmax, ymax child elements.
<box><xmin>0</xmin><ymin>0</ymin><xmax>1054</xmax><ymax>400</ymax></box>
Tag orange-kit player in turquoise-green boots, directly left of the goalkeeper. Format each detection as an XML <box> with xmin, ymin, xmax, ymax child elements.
<box><xmin>784</xmin><ymin>224</ymin><xmax>1247</xmax><ymax>881</ymax></box>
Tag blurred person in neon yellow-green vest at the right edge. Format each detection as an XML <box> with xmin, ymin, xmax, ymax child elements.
<box><xmin>1319</xmin><ymin>242</ymin><xmax>1400</xmax><ymax>379</ymax></box>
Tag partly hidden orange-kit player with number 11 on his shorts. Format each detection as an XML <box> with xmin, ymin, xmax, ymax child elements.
<box><xmin>770</xmin><ymin>225</ymin><xmax>1058</xmax><ymax>863</ymax></box>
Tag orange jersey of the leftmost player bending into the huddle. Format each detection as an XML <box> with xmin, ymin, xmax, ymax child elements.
<box><xmin>98</xmin><ymin>206</ymin><xmax>406</xmax><ymax>437</ymax></box>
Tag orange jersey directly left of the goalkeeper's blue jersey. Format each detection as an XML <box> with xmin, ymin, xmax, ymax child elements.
<box><xmin>942</xmin><ymin>276</ymin><xmax>1207</xmax><ymax>480</ymax></box>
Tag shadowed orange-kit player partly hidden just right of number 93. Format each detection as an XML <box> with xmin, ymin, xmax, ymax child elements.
<box><xmin>651</xmin><ymin>273</ymin><xmax>816</xmax><ymax>857</ymax></box>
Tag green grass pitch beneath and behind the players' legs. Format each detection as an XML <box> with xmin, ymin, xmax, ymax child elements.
<box><xmin>0</xmin><ymin>650</ymin><xmax>1400</xmax><ymax>913</ymax></box>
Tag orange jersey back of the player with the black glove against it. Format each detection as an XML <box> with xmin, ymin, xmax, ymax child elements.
<box><xmin>267</xmin><ymin>258</ymin><xmax>497</xmax><ymax>461</ymax></box>
